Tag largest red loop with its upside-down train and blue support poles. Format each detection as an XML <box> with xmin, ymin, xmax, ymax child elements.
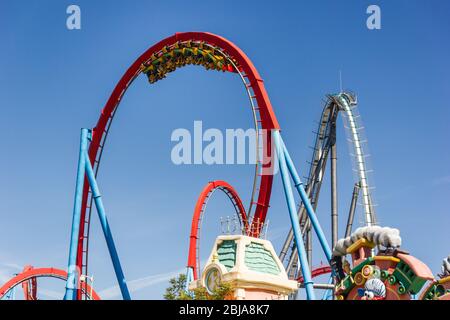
<box><xmin>61</xmin><ymin>32</ymin><xmax>331</xmax><ymax>299</ymax></box>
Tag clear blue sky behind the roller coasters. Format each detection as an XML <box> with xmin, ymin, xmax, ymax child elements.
<box><xmin>0</xmin><ymin>0</ymin><xmax>450</xmax><ymax>299</ymax></box>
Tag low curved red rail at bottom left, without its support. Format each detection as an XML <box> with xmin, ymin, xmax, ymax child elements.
<box><xmin>0</xmin><ymin>268</ymin><xmax>100</xmax><ymax>300</ymax></box>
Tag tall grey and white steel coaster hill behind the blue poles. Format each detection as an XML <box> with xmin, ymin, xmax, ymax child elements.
<box><xmin>280</xmin><ymin>93</ymin><xmax>376</xmax><ymax>284</ymax></box>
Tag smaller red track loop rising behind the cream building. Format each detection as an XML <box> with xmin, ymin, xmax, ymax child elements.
<box><xmin>188</xmin><ymin>180</ymin><xmax>248</xmax><ymax>280</ymax></box>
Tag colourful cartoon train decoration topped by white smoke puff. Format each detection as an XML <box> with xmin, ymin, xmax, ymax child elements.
<box><xmin>333</xmin><ymin>226</ymin><xmax>434</xmax><ymax>300</ymax></box>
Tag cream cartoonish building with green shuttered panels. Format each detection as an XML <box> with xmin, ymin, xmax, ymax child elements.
<box><xmin>189</xmin><ymin>235</ymin><xmax>298</xmax><ymax>300</ymax></box>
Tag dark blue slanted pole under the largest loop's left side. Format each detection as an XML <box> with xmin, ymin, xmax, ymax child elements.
<box><xmin>86</xmin><ymin>153</ymin><xmax>131</xmax><ymax>300</ymax></box>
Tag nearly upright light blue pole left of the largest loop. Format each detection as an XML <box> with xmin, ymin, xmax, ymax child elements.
<box><xmin>64</xmin><ymin>129</ymin><xmax>89</xmax><ymax>300</ymax></box>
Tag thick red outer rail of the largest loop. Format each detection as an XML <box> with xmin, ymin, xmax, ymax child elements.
<box><xmin>77</xmin><ymin>32</ymin><xmax>279</xmax><ymax>298</ymax></box>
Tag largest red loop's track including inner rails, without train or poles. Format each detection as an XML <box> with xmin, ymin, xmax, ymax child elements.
<box><xmin>77</xmin><ymin>32</ymin><xmax>279</xmax><ymax>298</ymax></box>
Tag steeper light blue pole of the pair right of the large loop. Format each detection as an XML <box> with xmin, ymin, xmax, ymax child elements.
<box><xmin>273</xmin><ymin>130</ymin><xmax>316</xmax><ymax>300</ymax></box>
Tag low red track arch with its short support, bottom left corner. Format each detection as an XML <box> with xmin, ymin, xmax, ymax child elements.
<box><xmin>0</xmin><ymin>266</ymin><xmax>100</xmax><ymax>300</ymax></box>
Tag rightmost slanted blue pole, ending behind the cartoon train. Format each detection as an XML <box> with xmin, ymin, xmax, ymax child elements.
<box><xmin>280</xmin><ymin>137</ymin><xmax>332</xmax><ymax>261</ymax></box>
